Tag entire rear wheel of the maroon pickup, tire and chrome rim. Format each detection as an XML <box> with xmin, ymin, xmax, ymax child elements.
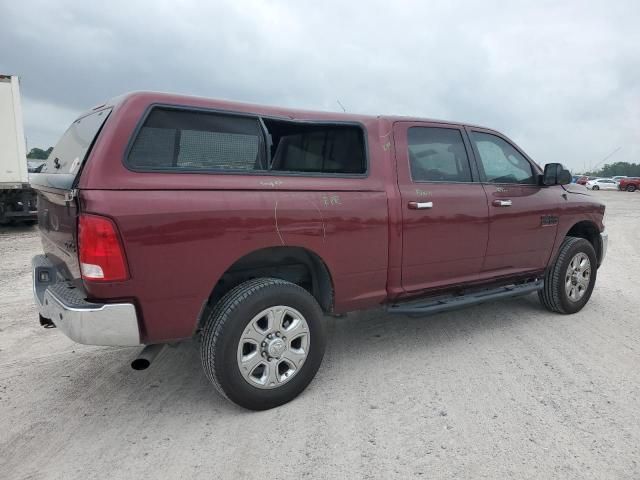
<box><xmin>201</xmin><ymin>278</ymin><xmax>326</xmax><ymax>410</ymax></box>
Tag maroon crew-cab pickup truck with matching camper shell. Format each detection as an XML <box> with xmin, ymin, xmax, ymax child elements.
<box><xmin>32</xmin><ymin>92</ymin><xmax>607</xmax><ymax>410</ymax></box>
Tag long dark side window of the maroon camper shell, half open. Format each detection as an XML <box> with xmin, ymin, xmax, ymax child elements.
<box><xmin>125</xmin><ymin>106</ymin><xmax>367</xmax><ymax>175</ymax></box>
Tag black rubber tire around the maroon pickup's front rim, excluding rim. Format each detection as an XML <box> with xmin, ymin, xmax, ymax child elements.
<box><xmin>538</xmin><ymin>237</ymin><xmax>598</xmax><ymax>314</ymax></box>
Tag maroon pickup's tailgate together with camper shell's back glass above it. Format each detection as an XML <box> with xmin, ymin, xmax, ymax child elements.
<box><xmin>30</xmin><ymin>109</ymin><xmax>111</xmax><ymax>279</ymax></box>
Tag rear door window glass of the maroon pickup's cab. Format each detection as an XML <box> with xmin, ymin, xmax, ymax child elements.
<box><xmin>407</xmin><ymin>127</ymin><xmax>471</xmax><ymax>182</ymax></box>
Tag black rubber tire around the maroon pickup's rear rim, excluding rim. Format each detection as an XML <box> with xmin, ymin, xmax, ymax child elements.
<box><xmin>200</xmin><ymin>278</ymin><xmax>326</xmax><ymax>410</ymax></box>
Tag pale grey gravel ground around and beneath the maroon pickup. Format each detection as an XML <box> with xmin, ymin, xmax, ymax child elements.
<box><xmin>0</xmin><ymin>192</ymin><xmax>640</xmax><ymax>479</ymax></box>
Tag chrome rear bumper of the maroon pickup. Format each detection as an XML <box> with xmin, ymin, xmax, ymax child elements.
<box><xmin>32</xmin><ymin>255</ymin><xmax>141</xmax><ymax>346</ymax></box>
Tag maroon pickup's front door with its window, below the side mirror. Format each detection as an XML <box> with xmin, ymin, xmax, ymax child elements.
<box><xmin>468</xmin><ymin>128</ymin><xmax>564</xmax><ymax>277</ymax></box>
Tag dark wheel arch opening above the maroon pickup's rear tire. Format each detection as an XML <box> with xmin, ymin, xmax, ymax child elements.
<box><xmin>199</xmin><ymin>246</ymin><xmax>334</xmax><ymax>323</ymax></box>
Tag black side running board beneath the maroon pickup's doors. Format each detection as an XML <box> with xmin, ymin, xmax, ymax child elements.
<box><xmin>386</xmin><ymin>279</ymin><xmax>544</xmax><ymax>315</ymax></box>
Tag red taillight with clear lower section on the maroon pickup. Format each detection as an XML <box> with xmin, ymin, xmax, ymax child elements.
<box><xmin>78</xmin><ymin>214</ymin><xmax>129</xmax><ymax>282</ymax></box>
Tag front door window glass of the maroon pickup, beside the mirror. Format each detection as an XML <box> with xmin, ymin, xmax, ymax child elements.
<box><xmin>471</xmin><ymin>132</ymin><xmax>536</xmax><ymax>185</ymax></box>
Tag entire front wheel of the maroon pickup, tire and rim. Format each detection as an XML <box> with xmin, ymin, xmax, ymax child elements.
<box><xmin>538</xmin><ymin>237</ymin><xmax>598</xmax><ymax>313</ymax></box>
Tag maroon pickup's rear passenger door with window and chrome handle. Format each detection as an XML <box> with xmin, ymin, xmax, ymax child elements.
<box><xmin>394</xmin><ymin>122</ymin><xmax>488</xmax><ymax>292</ymax></box>
